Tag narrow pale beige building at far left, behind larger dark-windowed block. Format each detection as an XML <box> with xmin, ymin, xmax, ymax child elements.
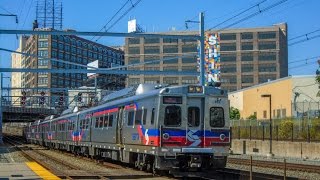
<box><xmin>11</xmin><ymin>36</ymin><xmax>28</xmax><ymax>105</ymax></box>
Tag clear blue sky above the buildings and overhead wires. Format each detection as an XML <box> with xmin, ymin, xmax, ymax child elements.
<box><xmin>0</xmin><ymin>0</ymin><xmax>320</xmax><ymax>86</ymax></box>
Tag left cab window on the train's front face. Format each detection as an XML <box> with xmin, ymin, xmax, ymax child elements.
<box><xmin>164</xmin><ymin>105</ymin><xmax>181</xmax><ymax>126</ymax></box>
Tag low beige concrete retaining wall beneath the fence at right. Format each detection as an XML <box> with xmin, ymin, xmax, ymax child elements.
<box><xmin>231</xmin><ymin>140</ymin><xmax>320</xmax><ymax>160</ymax></box>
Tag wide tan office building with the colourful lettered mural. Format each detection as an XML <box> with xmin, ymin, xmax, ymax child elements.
<box><xmin>125</xmin><ymin>23</ymin><xmax>288</xmax><ymax>91</ymax></box>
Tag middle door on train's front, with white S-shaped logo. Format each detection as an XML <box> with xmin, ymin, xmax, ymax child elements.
<box><xmin>186</xmin><ymin>97</ymin><xmax>205</xmax><ymax>147</ymax></box>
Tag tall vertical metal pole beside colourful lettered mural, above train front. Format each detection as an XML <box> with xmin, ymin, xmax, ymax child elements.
<box><xmin>199</xmin><ymin>12</ymin><xmax>205</xmax><ymax>86</ymax></box>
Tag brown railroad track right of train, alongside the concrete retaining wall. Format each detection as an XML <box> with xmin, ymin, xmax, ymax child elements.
<box><xmin>228</xmin><ymin>157</ymin><xmax>320</xmax><ymax>173</ymax></box>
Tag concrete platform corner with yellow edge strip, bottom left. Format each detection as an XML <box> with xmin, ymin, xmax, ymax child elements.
<box><xmin>0</xmin><ymin>162</ymin><xmax>60</xmax><ymax>180</ymax></box>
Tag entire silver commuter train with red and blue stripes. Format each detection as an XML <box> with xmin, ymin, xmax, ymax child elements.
<box><xmin>24</xmin><ymin>84</ymin><xmax>230</xmax><ymax>173</ymax></box>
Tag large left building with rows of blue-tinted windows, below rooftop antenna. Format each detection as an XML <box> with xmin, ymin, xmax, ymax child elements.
<box><xmin>17</xmin><ymin>29</ymin><xmax>125</xmax><ymax>107</ymax></box>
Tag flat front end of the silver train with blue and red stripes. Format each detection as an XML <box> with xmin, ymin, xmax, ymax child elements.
<box><xmin>156</xmin><ymin>85</ymin><xmax>230</xmax><ymax>171</ymax></box>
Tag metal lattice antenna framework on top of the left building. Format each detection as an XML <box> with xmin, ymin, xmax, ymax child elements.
<box><xmin>36</xmin><ymin>0</ymin><xmax>63</xmax><ymax>30</ymax></box>
